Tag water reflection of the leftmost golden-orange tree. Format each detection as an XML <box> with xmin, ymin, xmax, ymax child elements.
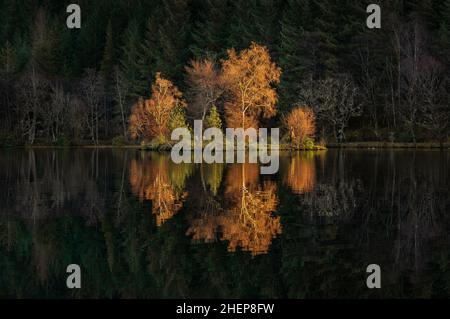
<box><xmin>130</xmin><ymin>156</ymin><xmax>187</xmax><ymax>226</ymax></box>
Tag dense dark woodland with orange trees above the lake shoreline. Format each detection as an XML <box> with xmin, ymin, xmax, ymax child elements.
<box><xmin>0</xmin><ymin>0</ymin><xmax>450</xmax><ymax>145</ymax></box>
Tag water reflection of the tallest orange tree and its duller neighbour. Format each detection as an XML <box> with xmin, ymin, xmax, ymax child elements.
<box><xmin>187</xmin><ymin>164</ymin><xmax>281</xmax><ymax>256</ymax></box>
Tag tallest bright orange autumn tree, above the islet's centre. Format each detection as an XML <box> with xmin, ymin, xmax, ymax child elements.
<box><xmin>222</xmin><ymin>43</ymin><xmax>281</xmax><ymax>129</ymax></box>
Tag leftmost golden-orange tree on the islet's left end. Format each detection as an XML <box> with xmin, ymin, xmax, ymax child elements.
<box><xmin>130</xmin><ymin>72</ymin><xmax>186</xmax><ymax>139</ymax></box>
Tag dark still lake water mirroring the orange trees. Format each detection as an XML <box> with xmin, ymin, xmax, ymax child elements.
<box><xmin>0</xmin><ymin>149</ymin><xmax>450</xmax><ymax>298</ymax></box>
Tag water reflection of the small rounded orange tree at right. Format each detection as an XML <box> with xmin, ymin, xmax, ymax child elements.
<box><xmin>284</xmin><ymin>152</ymin><xmax>316</xmax><ymax>194</ymax></box>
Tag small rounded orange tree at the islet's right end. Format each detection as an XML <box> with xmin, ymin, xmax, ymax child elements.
<box><xmin>285</xmin><ymin>107</ymin><xmax>316</xmax><ymax>148</ymax></box>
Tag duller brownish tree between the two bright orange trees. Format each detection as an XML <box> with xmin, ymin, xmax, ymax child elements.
<box><xmin>186</xmin><ymin>59</ymin><xmax>223</xmax><ymax>120</ymax></box>
